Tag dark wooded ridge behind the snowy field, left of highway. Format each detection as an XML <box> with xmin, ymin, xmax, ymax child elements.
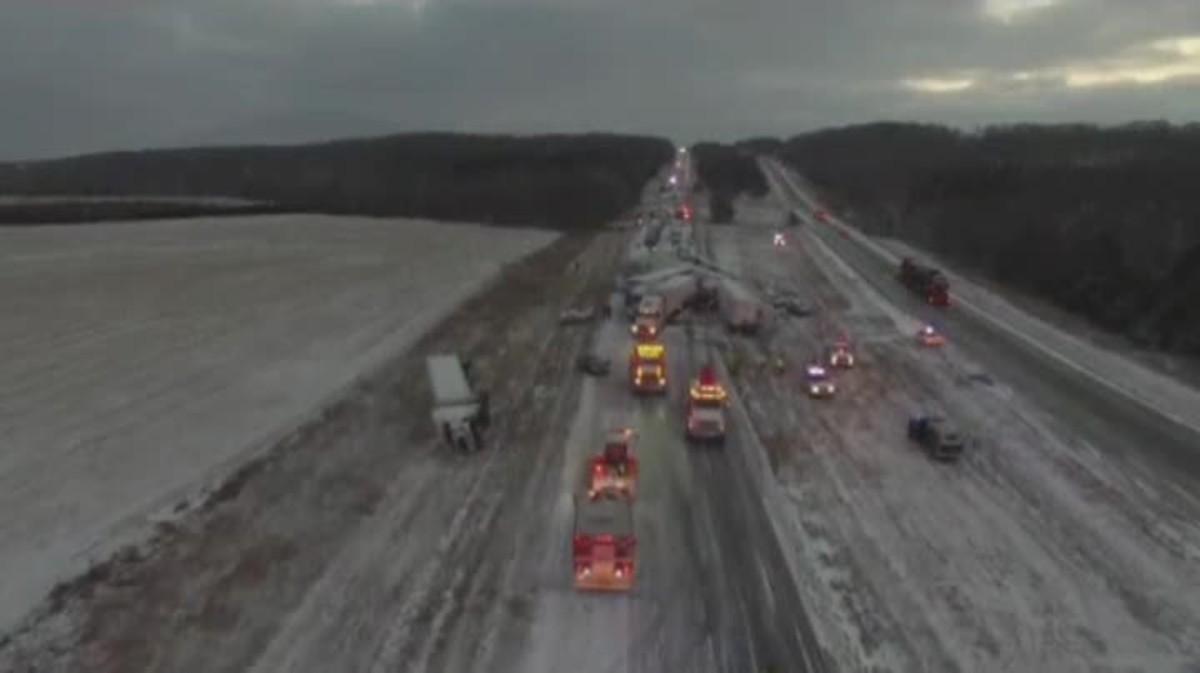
<box><xmin>0</xmin><ymin>133</ymin><xmax>673</xmax><ymax>229</ymax></box>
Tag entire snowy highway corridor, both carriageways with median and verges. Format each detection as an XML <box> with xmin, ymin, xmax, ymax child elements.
<box><xmin>0</xmin><ymin>158</ymin><xmax>1200</xmax><ymax>673</ymax></box>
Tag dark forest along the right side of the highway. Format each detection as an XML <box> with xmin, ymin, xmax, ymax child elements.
<box><xmin>773</xmin><ymin>122</ymin><xmax>1200</xmax><ymax>354</ymax></box>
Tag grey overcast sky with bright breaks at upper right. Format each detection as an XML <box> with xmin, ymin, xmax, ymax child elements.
<box><xmin>0</xmin><ymin>0</ymin><xmax>1200</xmax><ymax>160</ymax></box>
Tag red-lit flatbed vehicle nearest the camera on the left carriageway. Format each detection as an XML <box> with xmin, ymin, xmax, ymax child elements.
<box><xmin>571</xmin><ymin>498</ymin><xmax>637</xmax><ymax>591</ymax></box>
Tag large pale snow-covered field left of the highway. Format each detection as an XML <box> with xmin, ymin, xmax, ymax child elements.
<box><xmin>0</xmin><ymin>216</ymin><xmax>556</xmax><ymax>631</ymax></box>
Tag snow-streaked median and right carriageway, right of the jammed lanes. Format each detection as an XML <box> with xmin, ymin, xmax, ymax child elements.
<box><xmin>753</xmin><ymin>158</ymin><xmax>1200</xmax><ymax>672</ymax></box>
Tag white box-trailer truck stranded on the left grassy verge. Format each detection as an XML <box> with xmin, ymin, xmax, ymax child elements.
<box><xmin>425</xmin><ymin>355</ymin><xmax>491</xmax><ymax>451</ymax></box>
